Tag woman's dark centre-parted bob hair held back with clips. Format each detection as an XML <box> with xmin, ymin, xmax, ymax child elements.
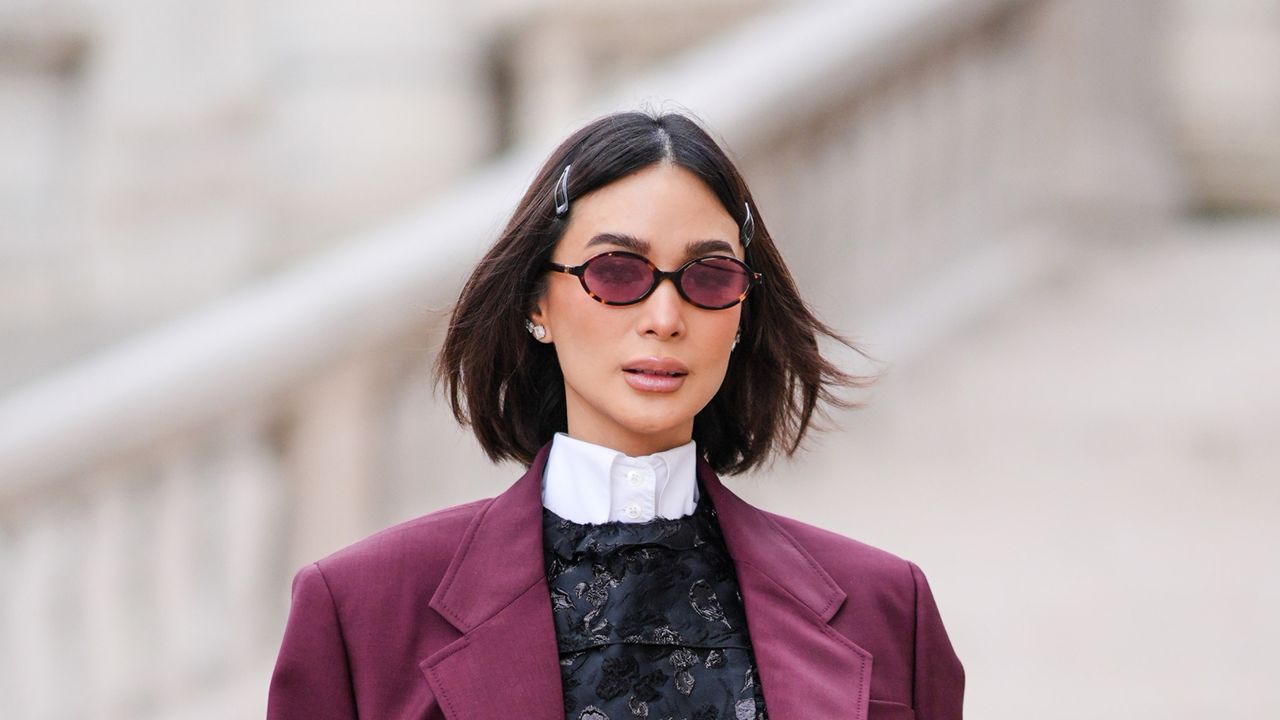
<box><xmin>435</xmin><ymin>113</ymin><xmax>869</xmax><ymax>474</ymax></box>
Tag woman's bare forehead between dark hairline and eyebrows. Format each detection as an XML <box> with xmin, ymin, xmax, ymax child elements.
<box><xmin>561</xmin><ymin>164</ymin><xmax>742</xmax><ymax>260</ymax></box>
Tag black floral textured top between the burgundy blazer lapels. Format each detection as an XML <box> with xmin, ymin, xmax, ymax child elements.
<box><xmin>543</xmin><ymin>484</ymin><xmax>768</xmax><ymax>720</ymax></box>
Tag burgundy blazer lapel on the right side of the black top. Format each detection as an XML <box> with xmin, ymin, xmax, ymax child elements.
<box><xmin>698</xmin><ymin>460</ymin><xmax>872</xmax><ymax>720</ymax></box>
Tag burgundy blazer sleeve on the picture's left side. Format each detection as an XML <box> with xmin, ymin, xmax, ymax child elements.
<box><xmin>266</xmin><ymin>564</ymin><xmax>356</xmax><ymax>720</ymax></box>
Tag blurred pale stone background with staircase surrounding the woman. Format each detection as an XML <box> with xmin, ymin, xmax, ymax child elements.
<box><xmin>0</xmin><ymin>0</ymin><xmax>1280</xmax><ymax>720</ymax></box>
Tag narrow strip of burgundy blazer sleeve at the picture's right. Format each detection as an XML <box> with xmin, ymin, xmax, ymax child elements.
<box><xmin>911</xmin><ymin>562</ymin><xmax>964</xmax><ymax>720</ymax></box>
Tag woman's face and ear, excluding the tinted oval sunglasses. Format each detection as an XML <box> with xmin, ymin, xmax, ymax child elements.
<box><xmin>532</xmin><ymin>163</ymin><xmax>742</xmax><ymax>456</ymax></box>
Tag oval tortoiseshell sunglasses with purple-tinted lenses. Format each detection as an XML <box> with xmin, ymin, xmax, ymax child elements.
<box><xmin>547</xmin><ymin>251</ymin><xmax>764</xmax><ymax>310</ymax></box>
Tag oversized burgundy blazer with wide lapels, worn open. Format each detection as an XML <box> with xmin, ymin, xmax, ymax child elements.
<box><xmin>266</xmin><ymin>445</ymin><xmax>964</xmax><ymax>720</ymax></box>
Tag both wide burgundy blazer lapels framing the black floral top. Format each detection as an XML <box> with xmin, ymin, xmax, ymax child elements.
<box><xmin>419</xmin><ymin>445</ymin><xmax>872</xmax><ymax>720</ymax></box>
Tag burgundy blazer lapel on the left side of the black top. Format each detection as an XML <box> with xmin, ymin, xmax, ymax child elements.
<box><xmin>419</xmin><ymin>445</ymin><xmax>564</xmax><ymax>720</ymax></box>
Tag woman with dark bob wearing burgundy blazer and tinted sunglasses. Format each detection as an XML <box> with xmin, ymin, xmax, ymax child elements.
<box><xmin>268</xmin><ymin>113</ymin><xmax>964</xmax><ymax>720</ymax></box>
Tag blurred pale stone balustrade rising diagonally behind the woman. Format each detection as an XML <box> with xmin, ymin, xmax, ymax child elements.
<box><xmin>0</xmin><ymin>0</ymin><xmax>1172</xmax><ymax>719</ymax></box>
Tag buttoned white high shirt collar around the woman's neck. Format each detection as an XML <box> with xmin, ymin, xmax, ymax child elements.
<box><xmin>543</xmin><ymin>433</ymin><xmax>698</xmax><ymax>524</ymax></box>
